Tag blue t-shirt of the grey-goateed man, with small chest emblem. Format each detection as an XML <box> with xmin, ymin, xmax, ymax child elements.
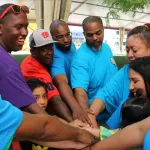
<box><xmin>71</xmin><ymin>43</ymin><xmax>118</xmax><ymax>104</ymax></box>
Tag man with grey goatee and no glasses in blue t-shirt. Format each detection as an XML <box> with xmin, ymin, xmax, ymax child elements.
<box><xmin>71</xmin><ymin>16</ymin><xmax>118</xmax><ymax>126</ymax></box>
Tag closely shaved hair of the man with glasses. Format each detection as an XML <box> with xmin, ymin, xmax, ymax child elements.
<box><xmin>49</xmin><ymin>19</ymin><xmax>67</xmax><ymax>35</ymax></box>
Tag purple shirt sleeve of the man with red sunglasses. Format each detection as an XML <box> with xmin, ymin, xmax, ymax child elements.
<box><xmin>0</xmin><ymin>69</ymin><xmax>36</xmax><ymax>108</ymax></box>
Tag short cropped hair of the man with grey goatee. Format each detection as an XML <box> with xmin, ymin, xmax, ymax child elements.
<box><xmin>82</xmin><ymin>16</ymin><xmax>103</xmax><ymax>31</ymax></box>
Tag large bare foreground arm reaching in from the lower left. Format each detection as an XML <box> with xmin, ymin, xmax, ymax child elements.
<box><xmin>15</xmin><ymin>112</ymin><xmax>94</xmax><ymax>144</ymax></box>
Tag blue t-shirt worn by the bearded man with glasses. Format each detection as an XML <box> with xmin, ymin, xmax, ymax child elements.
<box><xmin>50</xmin><ymin>43</ymin><xmax>76</xmax><ymax>85</ymax></box>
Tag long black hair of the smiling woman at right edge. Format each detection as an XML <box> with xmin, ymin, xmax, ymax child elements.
<box><xmin>129</xmin><ymin>56</ymin><xmax>150</xmax><ymax>97</ymax></box>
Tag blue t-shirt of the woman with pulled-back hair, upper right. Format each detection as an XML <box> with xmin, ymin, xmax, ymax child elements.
<box><xmin>95</xmin><ymin>65</ymin><xmax>130</xmax><ymax>115</ymax></box>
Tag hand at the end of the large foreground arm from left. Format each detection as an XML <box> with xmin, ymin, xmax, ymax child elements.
<box><xmin>77</xmin><ymin>129</ymin><xmax>95</xmax><ymax>144</ymax></box>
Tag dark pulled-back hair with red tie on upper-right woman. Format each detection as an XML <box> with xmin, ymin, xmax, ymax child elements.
<box><xmin>127</xmin><ymin>23</ymin><xmax>150</xmax><ymax>47</ymax></box>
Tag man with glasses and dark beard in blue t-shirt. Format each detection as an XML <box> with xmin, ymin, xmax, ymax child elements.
<box><xmin>50</xmin><ymin>20</ymin><xmax>91</xmax><ymax>124</ymax></box>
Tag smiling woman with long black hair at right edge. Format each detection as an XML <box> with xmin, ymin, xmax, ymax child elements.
<box><xmin>129</xmin><ymin>56</ymin><xmax>150</xmax><ymax>97</ymax></box>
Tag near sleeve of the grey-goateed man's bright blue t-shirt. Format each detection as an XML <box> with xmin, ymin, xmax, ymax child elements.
<box><xmin>70</xmin><ymin>53</ymin><xmax>90</xmax><ymax>91</ymax></box>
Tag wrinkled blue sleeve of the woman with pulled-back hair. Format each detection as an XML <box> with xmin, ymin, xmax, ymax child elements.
<box><xmin>95</xmin><ymin>68</ymin><xmax>127</xmax><ymax>114</ymax></box>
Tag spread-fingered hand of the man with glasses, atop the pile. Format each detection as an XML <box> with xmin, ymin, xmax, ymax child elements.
<box><xmin>73</xmin><ymin>106</ymin><xmax>94</xmax><ymax>126</ymax></box>
